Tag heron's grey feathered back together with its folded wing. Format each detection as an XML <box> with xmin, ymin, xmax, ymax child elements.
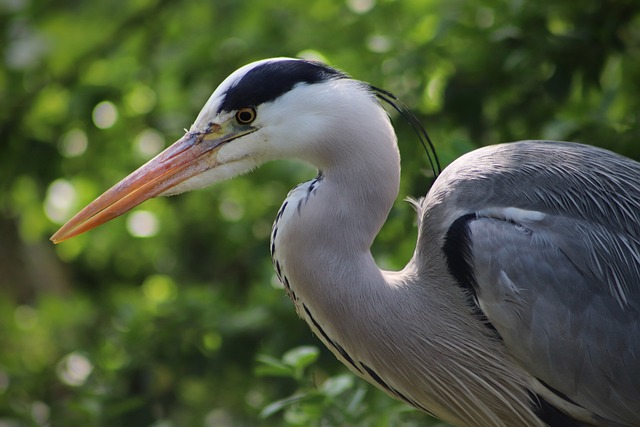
<box><xmin>414</xmin><ymin>141</ymin><xmax>640</xmax><ymax>425</ymax></box>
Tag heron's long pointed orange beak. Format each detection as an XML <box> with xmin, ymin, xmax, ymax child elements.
<box><xmin>51</xmin><ymin>122</ymin><xmax>255</xmax><ymax>243</ymax></box>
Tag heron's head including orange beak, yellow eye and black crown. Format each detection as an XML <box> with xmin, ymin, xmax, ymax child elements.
<box><xmin>51</xmin><ymin>58</ymin><xmax>388</xmax><ymax>243</ymax></box>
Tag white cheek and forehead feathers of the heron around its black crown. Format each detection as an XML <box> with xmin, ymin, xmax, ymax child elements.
<box><xmin>162</xmin><ymin>58</ymin><xmax>387</xmax><ymax>195</ymax></box>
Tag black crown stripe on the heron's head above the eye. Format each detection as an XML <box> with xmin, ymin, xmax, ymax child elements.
<box><xmin>218</xmin><ymin>59</ymin><xmax>349</xmax><ymax>112</ymax></box>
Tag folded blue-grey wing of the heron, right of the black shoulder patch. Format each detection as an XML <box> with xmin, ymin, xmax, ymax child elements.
<box><xmin>467</xmin><ymin>208</ymin><xmax>640</xmax><ymax>425</ymax></box>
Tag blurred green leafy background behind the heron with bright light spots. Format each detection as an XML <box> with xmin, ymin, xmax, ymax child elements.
<box><xmin>0</xmin><ymin>0</ymin><xmax>640</xmax><ymax>427</ymax></box>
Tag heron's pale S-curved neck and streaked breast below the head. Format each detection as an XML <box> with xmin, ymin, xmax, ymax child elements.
<box><xmin>271</xmin><ymin>103</ymin><xmax>540</xmax><ymax>426</ymax></box>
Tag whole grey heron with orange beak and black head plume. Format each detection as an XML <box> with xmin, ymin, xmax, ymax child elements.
<box><xmin>52</xmin><ymin>58</ymin><xmax>640</xmax><ymax>426</ymax></box>
